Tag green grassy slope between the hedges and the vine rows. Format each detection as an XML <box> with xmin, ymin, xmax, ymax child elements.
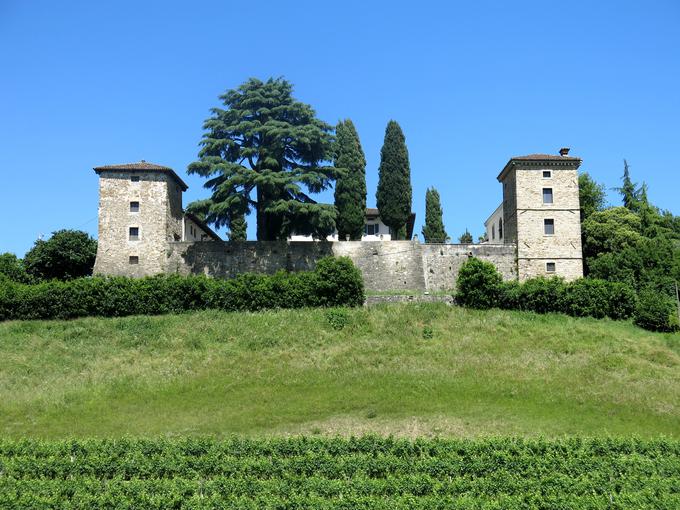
<box><xmin>0</xmin><ymin>304</ymin><xmax>680</xmax><ymax>438</ymax></box>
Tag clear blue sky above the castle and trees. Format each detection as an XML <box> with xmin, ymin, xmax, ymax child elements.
<box><xmin>0</xmin><ymin>0</ymin><xmax>680</xmax><ymax>256</ymax></box>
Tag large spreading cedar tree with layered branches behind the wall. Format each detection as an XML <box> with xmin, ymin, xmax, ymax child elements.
<box><xmin>188</xmin><ymin>78</ymin><xmax>335</xmax><ymax>240</ymax></box>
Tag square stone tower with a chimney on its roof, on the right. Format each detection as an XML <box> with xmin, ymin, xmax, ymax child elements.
<box><xmin>498</xmin><ymin>148</ymin><xmax>583</xmax><ymax>281</ymax></box>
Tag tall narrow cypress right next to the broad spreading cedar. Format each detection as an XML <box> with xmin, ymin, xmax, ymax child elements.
<box><xmin>334</xmin><ymin>119</ymin><xmax>366</xmax><ymax>241</ymax></box>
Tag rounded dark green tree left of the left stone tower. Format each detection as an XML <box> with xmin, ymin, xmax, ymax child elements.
<box><xmin>24</xmin><ymin>230</ymin><xmax>97</xmax><ymax>280</ymax></box>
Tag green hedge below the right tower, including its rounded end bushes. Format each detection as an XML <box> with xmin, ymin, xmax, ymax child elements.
<box><xmin>456</xmin><ymin>258</ymin><xmax>680</xmax><ymax>331</ymax></box>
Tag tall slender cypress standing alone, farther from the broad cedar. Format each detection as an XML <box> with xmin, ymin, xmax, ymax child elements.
<box><xmin>376</xmin><ymin>120</ymin><xmax>412</xmax><ymax>237</ymax></box>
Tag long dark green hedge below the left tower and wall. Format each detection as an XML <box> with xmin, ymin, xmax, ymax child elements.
<box><xmin>0</xmin><ymin>257</ymin><xmax>364</xmax><ymax>320</ymax></box>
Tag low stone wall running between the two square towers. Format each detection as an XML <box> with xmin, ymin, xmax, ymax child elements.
<box><xmin>165</xmin><ymin>241</ymin><xmax>517</xmax><ymax>292</ymax></box>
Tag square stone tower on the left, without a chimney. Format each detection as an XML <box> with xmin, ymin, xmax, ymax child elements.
<box><xmin>94</xmin><ymin>160</ymin><xmax>187</xmax><ymax>276</ymax></box>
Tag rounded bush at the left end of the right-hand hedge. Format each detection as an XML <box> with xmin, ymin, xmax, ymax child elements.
<box><xmin>456</xmin><ymin>257</ymin><xmax>503</xmax><ymax>310</ymax></box>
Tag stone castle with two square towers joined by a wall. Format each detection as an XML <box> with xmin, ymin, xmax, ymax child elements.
<box><xmin>94</xmin><ymin>149</ymin><xmax>583</xmax><ymax>291</ymax></box>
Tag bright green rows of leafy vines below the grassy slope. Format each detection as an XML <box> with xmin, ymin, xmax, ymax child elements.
<box><xmin>0</xmin><ymin>436</ymin><xmax>680</xmax><ymax>509</ymax></box>
